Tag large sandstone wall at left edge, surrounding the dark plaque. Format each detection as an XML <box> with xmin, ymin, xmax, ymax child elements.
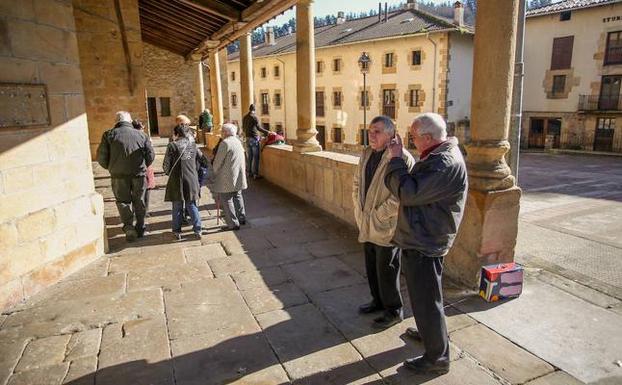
<box><xmin>0</xmin><ymin>0</ymin><xmax>104</xmax><ymax>309</ymax></box>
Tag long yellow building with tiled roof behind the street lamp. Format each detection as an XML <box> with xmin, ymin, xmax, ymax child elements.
<box><xmin>225</xmin><ymin>8</ymin><xmax>473</xmax><ymax>153</ymax></box>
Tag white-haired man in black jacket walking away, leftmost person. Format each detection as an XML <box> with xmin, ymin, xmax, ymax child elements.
<box><xmin>97</xmin><ymin>111</ymin><xmax>155</xmax><ymax>242</ymax></box>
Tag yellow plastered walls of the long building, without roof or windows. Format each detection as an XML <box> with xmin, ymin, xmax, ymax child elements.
<box><xmin>225</xmin><ymin>33</ymin><xmax>458</xmax><ymax>149</ymax></box>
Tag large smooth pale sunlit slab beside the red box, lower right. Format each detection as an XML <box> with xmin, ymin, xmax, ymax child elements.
<box><xmin>455</xmin><ymin>275</ymin><xmax>622</xmax><ymax>382</ymax></box>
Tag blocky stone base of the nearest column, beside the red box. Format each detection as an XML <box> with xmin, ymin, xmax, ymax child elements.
<box><xmin>444</xmin><ymin>187</ymin><xmax>521</xmax><ymax>288</ymax></box>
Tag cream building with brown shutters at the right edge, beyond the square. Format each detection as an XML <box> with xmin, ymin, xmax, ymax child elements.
<box><xmin>521</xmin><ymin>0</ymin><xmax>622</xmax><ymax>152</ymax></box>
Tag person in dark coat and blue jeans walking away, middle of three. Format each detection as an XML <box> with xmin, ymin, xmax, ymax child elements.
<box><xmin>163</xmin><ymin>124</ymin><xmax>207</xmax><ymax>240</ymax></box>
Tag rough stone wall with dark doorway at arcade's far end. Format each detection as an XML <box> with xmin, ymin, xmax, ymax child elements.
<box><xmin>143</xmin><ymin>43</ymin><xmax>211</xmax><ymax>137</ymax></box>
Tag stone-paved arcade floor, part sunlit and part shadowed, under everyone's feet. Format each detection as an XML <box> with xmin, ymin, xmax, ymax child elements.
<box><xmin>0</xmin><ymin>146</ymin><xmax>622</xmax><ymax>385</ymax></box>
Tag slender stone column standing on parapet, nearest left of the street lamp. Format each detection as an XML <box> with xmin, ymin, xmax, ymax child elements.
<box><xmin>294</xmin><ymin>0</ymin><xmax>322</xmax><ymax>152</ymax></box>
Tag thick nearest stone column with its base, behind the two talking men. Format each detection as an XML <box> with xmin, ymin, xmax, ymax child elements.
<box><xmin>446</xmin><ymin>0</ymin><xmax>521</xmax><ymax>287</ymax></box>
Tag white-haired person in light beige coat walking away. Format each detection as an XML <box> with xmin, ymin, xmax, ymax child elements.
<box><xmin>212</xmin><ymin>123</ymin><xmax>247</xmax><ymax>231</ymax></box>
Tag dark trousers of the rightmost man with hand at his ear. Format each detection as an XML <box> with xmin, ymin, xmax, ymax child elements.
<box><xmin>402</xmin><ymin>250</ymin><xmax>449</xmax><ymax>362</ymax></box>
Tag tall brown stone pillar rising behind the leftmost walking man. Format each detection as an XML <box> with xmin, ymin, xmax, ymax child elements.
<box><xmin>73</xmin><ymin>0</ymin><xmax>147</xmax><ymax>157</ymax></box>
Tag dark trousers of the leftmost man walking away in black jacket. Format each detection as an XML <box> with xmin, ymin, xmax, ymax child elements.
<box><xmin>111</xmin><ymin>176</ymin><xmax>147</xmax><ymax>231</ymax></box>
